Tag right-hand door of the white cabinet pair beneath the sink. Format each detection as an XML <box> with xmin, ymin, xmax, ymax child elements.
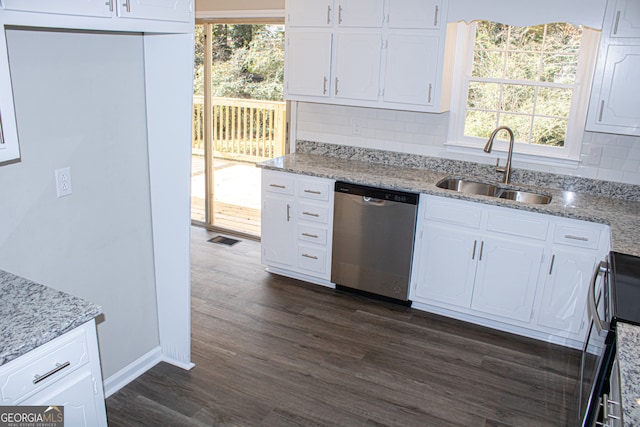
<box><xmin>471</xmin><ymin>237</ymin><xmax>543</xmax><ymax>322</ymax></box>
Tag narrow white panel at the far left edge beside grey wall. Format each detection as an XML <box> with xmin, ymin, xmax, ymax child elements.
<box><xmin>0</xmin><ymin>24</ymin><xmax>20</xmax><ymax>164</ymax></box>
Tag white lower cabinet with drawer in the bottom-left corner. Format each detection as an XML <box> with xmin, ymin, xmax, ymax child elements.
<box><xmin>0</xmin><ymin>320</ymin><xmax>107</xmax><ymax>427</ymax></box>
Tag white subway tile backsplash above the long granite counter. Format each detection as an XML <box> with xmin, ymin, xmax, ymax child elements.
<box><xmin>296</xmin><ymin>102</ymin><xmax>640</xmax><ymax>185</ymax></box>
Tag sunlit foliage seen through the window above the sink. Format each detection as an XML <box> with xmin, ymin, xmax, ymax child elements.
<box><xmin>464</xmin><ymin>21</ymin><xmax>582</xmax><ymax>147</ymax></box>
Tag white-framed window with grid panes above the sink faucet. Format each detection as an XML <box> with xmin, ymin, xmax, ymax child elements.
<box><xmin>453</xmin><ymin>21</ymin><xmax>598</xmax><ymax>164</ymax></box>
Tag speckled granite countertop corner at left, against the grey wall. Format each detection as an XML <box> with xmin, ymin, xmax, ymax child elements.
<box><xmin>0</xmin><ymin>270</ymin><xmax>102</xmax><ymax>366</ymax></box>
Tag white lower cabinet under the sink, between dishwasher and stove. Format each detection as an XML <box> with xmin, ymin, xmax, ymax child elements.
<box><xmin>410</xmin><ymin>195</ymin><xmax>609</xmax><ymax>347</ymax></box>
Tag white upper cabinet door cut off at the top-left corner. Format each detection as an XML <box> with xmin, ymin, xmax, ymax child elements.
<box><xmin>2</xmin><ymin>0</ymin><xmax>112</xmax><ymax>17</ymax></box>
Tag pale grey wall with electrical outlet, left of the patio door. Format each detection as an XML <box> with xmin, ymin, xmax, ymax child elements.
<box><xmin>0</xmin><ymin>30</ymin><xmax>159</xmax><ymax>378</ymax></box>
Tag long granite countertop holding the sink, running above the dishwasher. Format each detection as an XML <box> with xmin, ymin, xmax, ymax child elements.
<box><xmin>258</xmin><ymin>153</ymin><xmax>640</xmax><ymax>256</ymax></box>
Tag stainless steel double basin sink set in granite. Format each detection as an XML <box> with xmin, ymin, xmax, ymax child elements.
<box><xmin>436</xmin><ymin>178</ymin><xmax>551</xmax><ymax>205</ymax></box>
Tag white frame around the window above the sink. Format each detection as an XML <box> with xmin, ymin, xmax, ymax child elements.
<box><xmin>446</xmin><ymin>21</ymin><xmax>600</xmax><ymax>168</ymax></box>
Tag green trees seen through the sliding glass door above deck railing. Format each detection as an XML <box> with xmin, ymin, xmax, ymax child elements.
<box><xmin>194</xmin><ymin>25</ymin><xmax>284</xmax><ymax>101</ymax></box>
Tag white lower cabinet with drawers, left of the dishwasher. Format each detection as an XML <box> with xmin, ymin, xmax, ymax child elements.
<box><xmin>261</xmin><ymin>169</ymin><xmax>334</xmax><ymax>285</ymax></box>
